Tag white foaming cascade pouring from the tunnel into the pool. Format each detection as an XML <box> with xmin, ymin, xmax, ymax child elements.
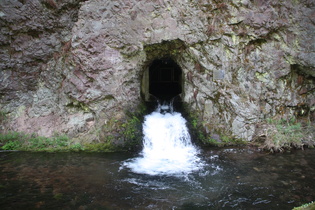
<box><xmin>123</xmin><ymin>105</ymin><xmax>203</xmax><ymax>175</ymax></box>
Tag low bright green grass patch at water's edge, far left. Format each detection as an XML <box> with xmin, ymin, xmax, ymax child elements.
<box><xmin>0</xmin><ymin>132</ymin><xmax>84</xmax><ymax>152</ymax></box>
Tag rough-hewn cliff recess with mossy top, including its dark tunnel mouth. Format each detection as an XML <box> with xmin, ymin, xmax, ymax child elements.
<box><xmin>141</xmin><ymin>39</ymin><xmax>186</xmax><ymax>102</ymax></box>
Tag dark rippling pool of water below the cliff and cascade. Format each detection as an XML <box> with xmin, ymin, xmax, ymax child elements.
<box><xmin>0</xmin><ymin>148</ymin><xmax>315</xmax><ymax>209</ymax></box>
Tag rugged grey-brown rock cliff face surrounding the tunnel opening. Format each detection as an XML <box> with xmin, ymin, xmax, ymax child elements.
<box><xmin>0</xmin><ymin>0</ymin><xmax>315</xmax><ymax>142</ymax></box>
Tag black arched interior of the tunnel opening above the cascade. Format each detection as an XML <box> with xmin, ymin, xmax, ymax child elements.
<box><xmin>149</xmin><ymin>58</ymin><xmax>182</xmax><ymax>101</ymax></box>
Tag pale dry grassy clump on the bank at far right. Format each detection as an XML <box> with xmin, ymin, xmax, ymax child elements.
<box><xmin>262</xmin><ymin>118</ymin><xmax>314</xmax><ymax>152</ymax></box>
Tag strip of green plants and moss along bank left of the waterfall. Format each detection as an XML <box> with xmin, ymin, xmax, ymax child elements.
<box><xmin>0</xmin><ymin>104</ymin><xmax>147</xmax><ymax>152</ymax></box>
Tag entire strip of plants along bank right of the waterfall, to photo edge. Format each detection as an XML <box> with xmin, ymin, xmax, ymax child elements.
<box><xmin>184</xmin><ymin>101</ymin><xmax>315</xmax><ymax>152</ymax></box>
